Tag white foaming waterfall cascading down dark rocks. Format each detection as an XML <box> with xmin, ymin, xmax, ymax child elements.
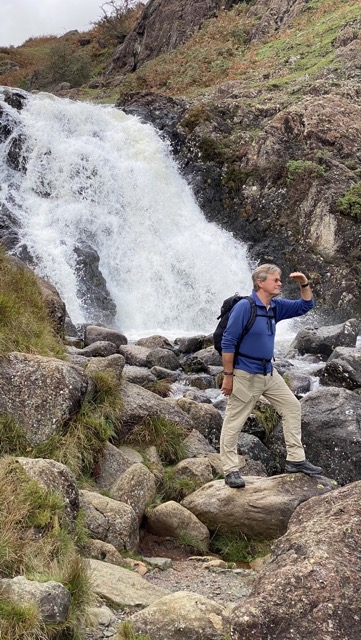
<box><xmin>0</xmin><ymin>94</ymin><xmax>255</xmax><ymax>338</ymax></box>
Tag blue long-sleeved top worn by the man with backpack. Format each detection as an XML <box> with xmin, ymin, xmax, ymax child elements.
<box><xmin>222</xmin><ymin>291</ymin><xmax>315</xmax><ymax>374</ymax></box>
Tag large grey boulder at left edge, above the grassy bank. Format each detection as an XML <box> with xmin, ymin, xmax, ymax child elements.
<box><xmin>0</xmin><ymin>353</ymin><xmax>88</xmax><ymax>444</ymax></box>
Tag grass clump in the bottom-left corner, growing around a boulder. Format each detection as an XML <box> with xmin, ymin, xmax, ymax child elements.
<box><xmin>0</xmin><ymin>458</ymin><xmax>95</xmax><ymax>640</ymax></box>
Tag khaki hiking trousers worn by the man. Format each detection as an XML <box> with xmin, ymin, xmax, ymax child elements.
<box><xmin>220</xmin><ymin>369</ymin><xmax>305</xmax><ymax>475</ymax></box>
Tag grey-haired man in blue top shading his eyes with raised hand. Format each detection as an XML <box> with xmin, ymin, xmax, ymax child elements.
<box><xmin>220</xmin><ymin>264</ymin><xmax>322</xmax><ymax>488</ymax></box>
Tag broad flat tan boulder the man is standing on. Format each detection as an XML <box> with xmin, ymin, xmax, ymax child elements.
<box><xmin>181</xmin><ymin>473</ymin><xmax>337</xmax><ymax>540</ymax></box>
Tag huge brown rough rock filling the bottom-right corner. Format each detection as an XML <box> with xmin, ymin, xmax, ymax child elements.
<box><xmin>231</xmin><ymin>482</ymin><xmax>361</xmax><ymax>640</ymax></box>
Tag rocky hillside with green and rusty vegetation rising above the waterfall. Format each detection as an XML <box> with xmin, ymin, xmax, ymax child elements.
<box><xmin>1</xmin><ymin>0</ymin><xmax>361</xmax><ymax>318</ymax></box>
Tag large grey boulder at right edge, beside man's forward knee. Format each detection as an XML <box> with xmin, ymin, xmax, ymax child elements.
<box><xmin>301</xmin><ymin>387</ymin><xmax>361</xmax><ymax>484</ymax></box>
